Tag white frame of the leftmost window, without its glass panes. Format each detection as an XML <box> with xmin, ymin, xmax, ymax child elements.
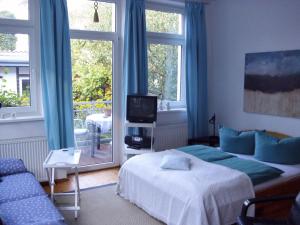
<box><xmin>0</xmin><ymin>0</ymin><xmax>42</xmax><ymax>116</ymax></box>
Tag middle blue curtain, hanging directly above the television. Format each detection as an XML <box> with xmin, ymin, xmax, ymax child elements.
<box><xmin>124</xmin><ymin>0</ymin><xmax>148</xmax><ymax>95</ymax></box>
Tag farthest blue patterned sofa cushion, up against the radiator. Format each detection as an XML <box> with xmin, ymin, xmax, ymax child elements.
<box><xmin>0</xmin><ymin>158</ymin><xmax>27</xmax><ymax>176</ymax></box>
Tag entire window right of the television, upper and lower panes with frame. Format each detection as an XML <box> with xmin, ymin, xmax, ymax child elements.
<box><xmin>146</xmin><ymin>6</ymin><xmax>185</xmax><ymax>108</ymax></box>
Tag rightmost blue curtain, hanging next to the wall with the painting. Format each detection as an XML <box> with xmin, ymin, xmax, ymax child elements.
<box><xmin>185</xmin><ymin>2</ymin><xmax>208</xmax><ymax>138</ymax></box>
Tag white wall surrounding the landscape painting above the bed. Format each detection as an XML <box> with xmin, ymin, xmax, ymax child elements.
<box><xmin>207</xmin><ymin>0</ymin><xmax>300</xmax><ymax>136</ymax></box>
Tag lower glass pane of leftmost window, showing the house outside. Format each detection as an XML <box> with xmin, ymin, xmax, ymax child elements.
<box><xmin>0</xmin><ymin>33</ymin><xmax>30</xmax><ymax>107</ymax></box>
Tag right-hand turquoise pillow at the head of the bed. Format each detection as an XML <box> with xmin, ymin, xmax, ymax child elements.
<box><xmin>255</xmin><ymin>132</ymin><xmax>300</xmax><ymax>165</ymax></box>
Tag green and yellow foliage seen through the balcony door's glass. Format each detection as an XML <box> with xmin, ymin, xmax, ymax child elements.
<box><xmin>71</xmin><ymin>40</ymin><xmax>112</xmax><ymax>102</ymax></box>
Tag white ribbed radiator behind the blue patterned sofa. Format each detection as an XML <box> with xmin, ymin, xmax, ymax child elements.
<box><xmin>0</xmin><ymin>137</ymin><xmax>49</xmax><ymax>181</ymax></box>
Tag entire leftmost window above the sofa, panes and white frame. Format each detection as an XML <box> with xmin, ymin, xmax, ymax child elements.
<box><xmin>0</xmin><ymin>0</ymin><xmax>39</xmax><ymax>117</ymax></box>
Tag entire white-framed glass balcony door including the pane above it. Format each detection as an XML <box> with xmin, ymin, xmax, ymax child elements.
<box><xmin>68</xmin><ymin>0</ymin><xmax>119</xmax><ymax>171</ymax></box>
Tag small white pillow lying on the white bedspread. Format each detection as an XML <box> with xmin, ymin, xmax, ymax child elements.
<box><xmin>160</xmin><ymin>155</ymin><xmax>191</xmax><ymax>170</ymax></box>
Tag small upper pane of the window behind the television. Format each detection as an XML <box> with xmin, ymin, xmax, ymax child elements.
<box><xmin>146</xmin><ymin>10</ymin><xmax>182</xmax><ymax>34</ymax></box>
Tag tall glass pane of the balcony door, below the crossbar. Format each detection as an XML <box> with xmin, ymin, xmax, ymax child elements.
<box><xmin>71</xmin><ymin>39</ymin><xmax>113</xmax><ymax>166</ymax></box>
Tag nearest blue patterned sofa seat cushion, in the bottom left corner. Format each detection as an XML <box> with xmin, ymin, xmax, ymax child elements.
<box><xmin>0</xmin><ymin>196</ymin><xmax>64</xmax><ymax>225</ymax></box>
